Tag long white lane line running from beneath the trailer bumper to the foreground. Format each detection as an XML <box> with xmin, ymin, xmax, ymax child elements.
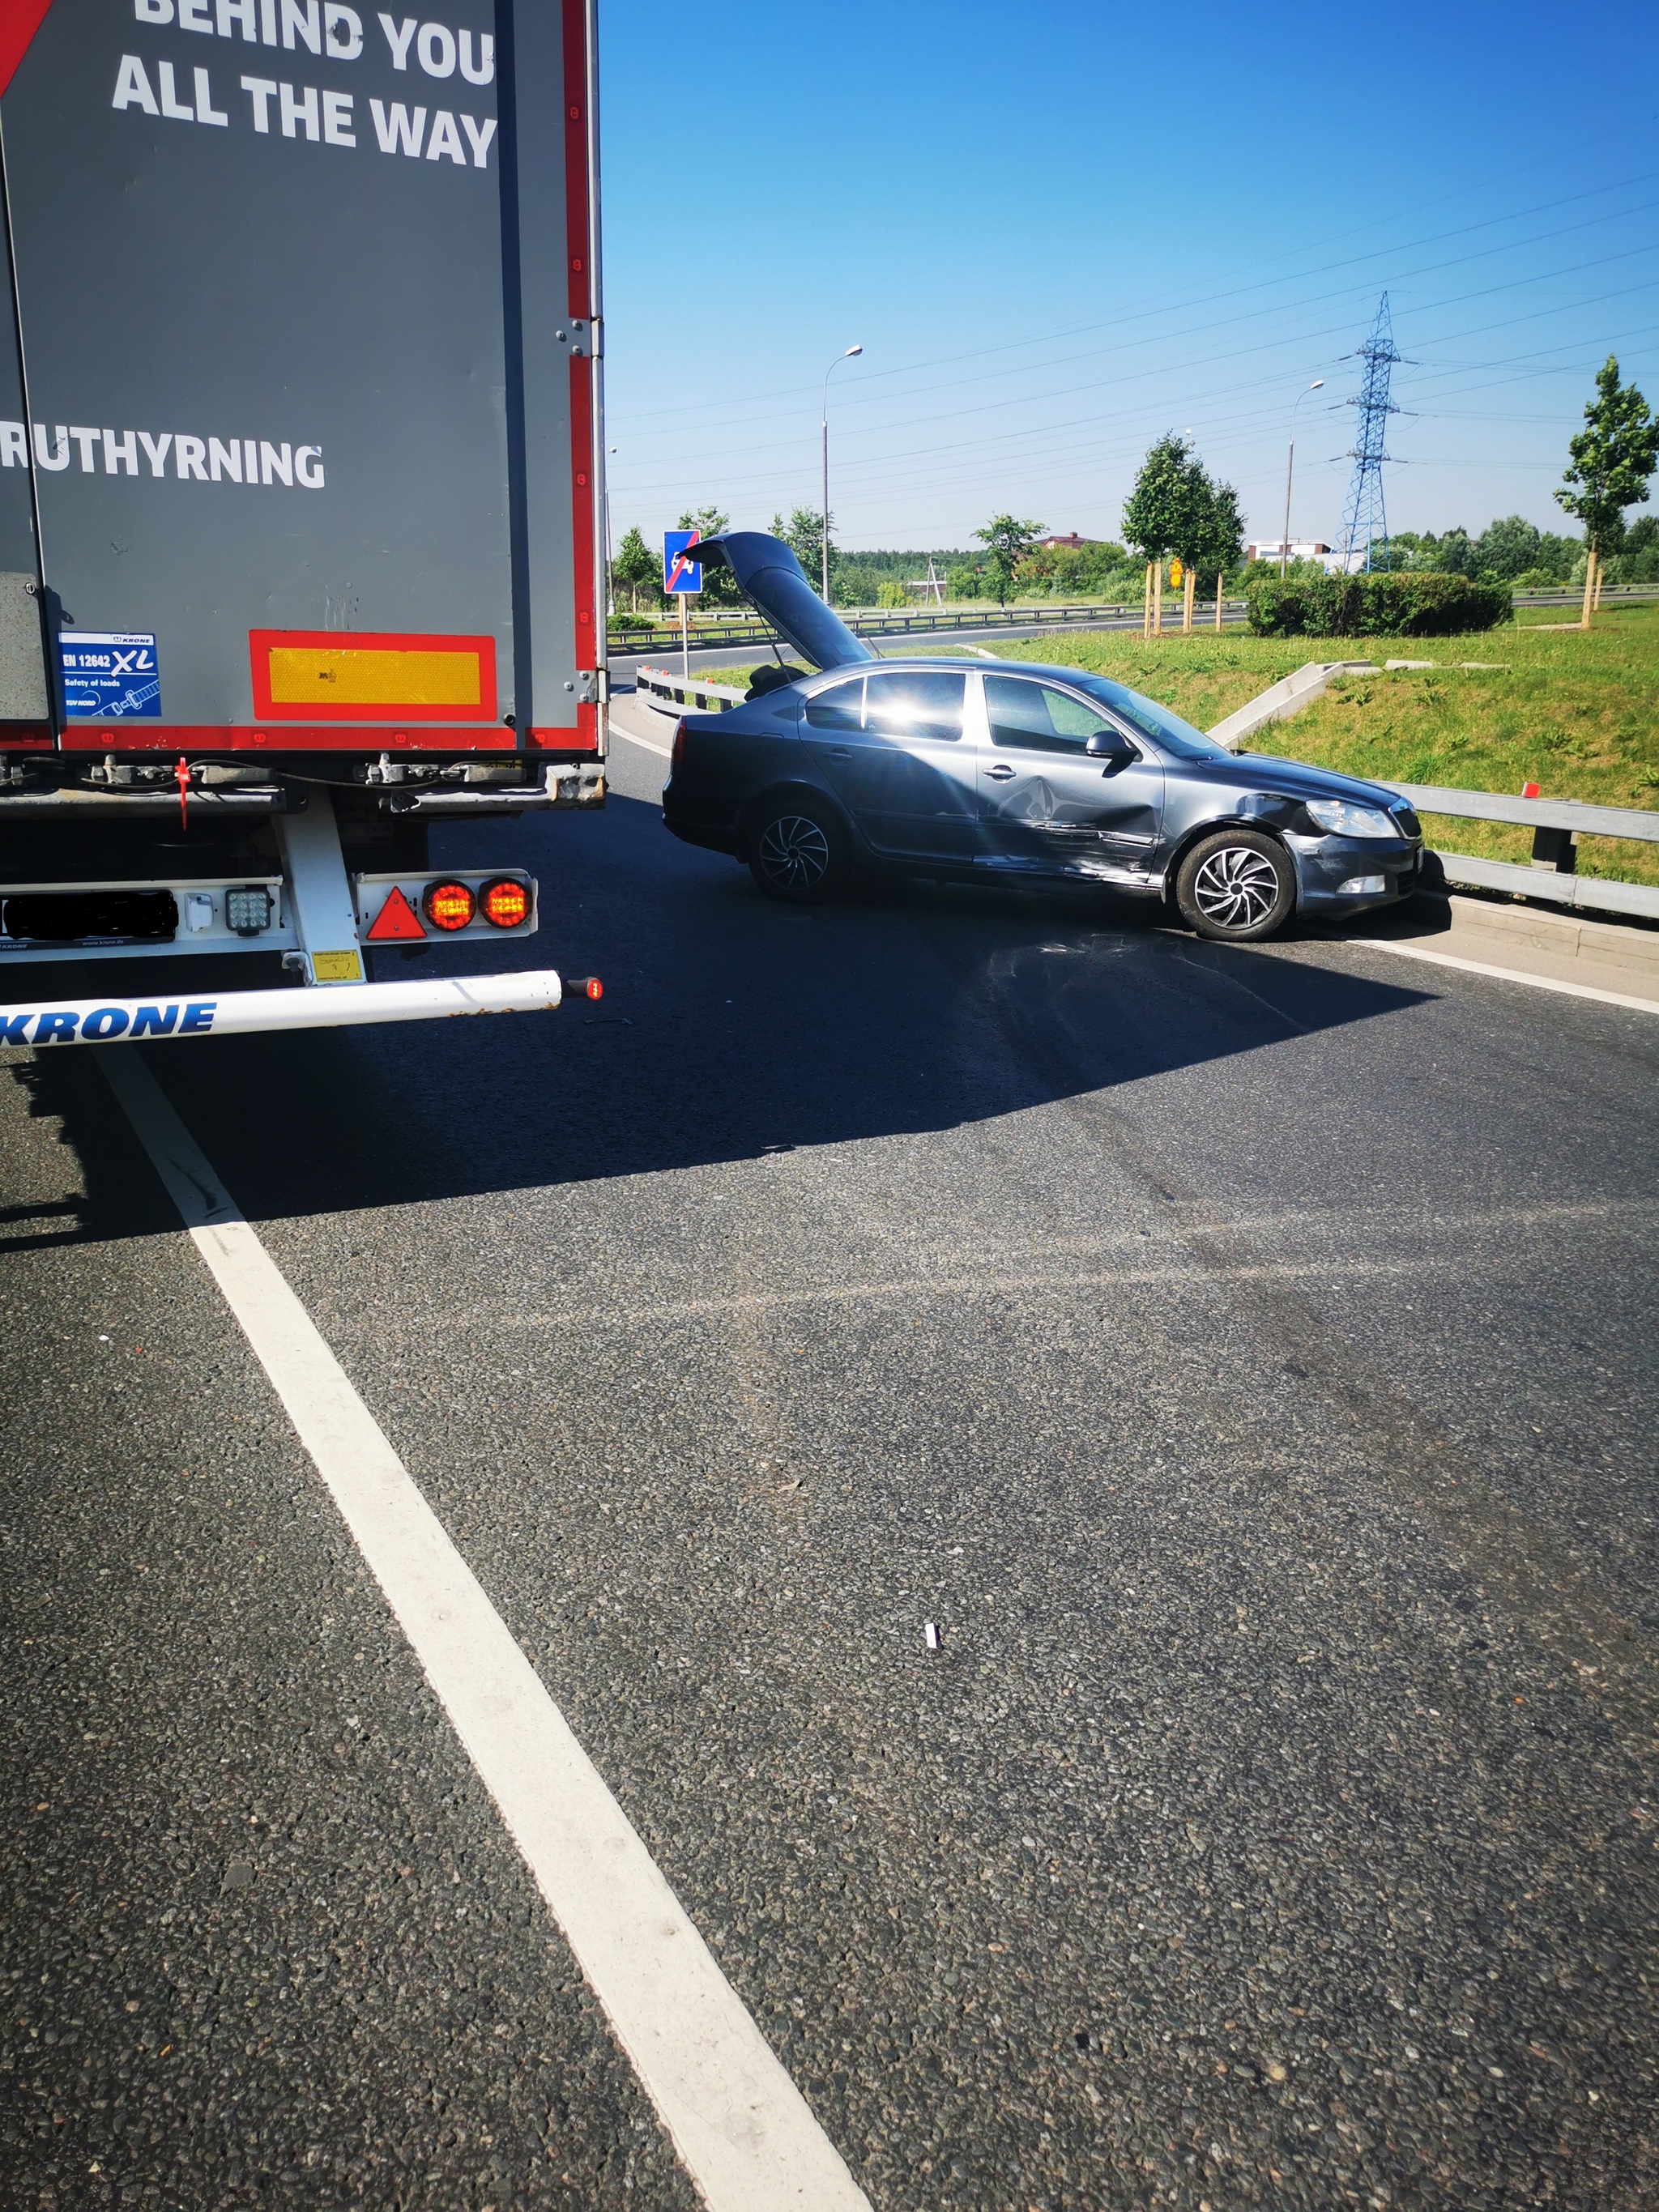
<box><xmin>97</xmin><ymin>1046</ymin><xmax>869</xmax><ymax>2212</ymax></box>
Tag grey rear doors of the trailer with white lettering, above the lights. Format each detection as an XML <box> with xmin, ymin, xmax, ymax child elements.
<box><xmin>0</xmin><ymin>0</ymin><xmax>599</xmax><ymax>750</ymax></box>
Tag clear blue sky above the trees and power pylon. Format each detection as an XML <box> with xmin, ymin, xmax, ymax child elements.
<box><xmin>599</xmin><ymin>0</ymin><xmax>1659</xmax><ymax>547</ymax></box>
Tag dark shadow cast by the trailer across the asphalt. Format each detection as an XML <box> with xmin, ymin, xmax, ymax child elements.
<box><xmin>0</xmin><ymin>796</ymin><xmax>1431</xmax><ymax>1250</ymax></box>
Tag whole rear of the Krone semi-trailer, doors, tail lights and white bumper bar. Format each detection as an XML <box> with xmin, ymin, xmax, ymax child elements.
<box><xmin>0</xmin><ymin>0</ymin><xmax>606</xmax><ymax>1044</ymax></box>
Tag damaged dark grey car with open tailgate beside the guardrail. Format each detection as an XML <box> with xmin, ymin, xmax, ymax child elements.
<box><xmin>663</xmin><ymin>531</ymin><xmax>1422</xmax><ymax>942</ymax></box>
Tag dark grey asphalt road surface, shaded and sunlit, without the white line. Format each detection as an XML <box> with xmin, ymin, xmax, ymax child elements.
<box><xmin>0</xmin><ymin>710</ymin><xmax>1659</xmax><ymax>2212</ymax></box>
